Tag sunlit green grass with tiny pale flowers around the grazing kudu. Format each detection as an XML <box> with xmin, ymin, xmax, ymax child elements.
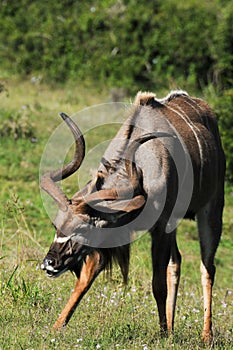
<box><xmin>0</xmin><ymin>78</ymin><xmax>233</xmax><ymax>350</ymax></box>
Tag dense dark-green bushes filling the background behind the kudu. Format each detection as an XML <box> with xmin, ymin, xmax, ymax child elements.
<box><xmin>0</xmin><ymin>0</ymin><xmax>233</xmax><ymax>91</ymax></box>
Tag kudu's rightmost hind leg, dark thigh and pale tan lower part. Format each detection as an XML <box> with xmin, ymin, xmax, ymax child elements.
<box><xmin>197</xmin><ymin>201</ymin><xmax>222</xmax><ymax>343</ymax></box>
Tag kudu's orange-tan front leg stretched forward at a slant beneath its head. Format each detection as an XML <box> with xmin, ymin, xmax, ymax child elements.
<box><xmin>53</xmin><ymin>252</ymin><xmax>101</xmax><ymax>329</ymax></box>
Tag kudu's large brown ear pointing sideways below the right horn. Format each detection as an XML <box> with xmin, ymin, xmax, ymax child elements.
<box><xmin>94</xmin><ymin>195</ymin><xmax>146</xmax><ymax>213</ymax></box>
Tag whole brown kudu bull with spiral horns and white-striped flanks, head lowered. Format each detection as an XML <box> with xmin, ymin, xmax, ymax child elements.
<box><xmin>41</xmin><ymin>91</ymin><xmax>225</xmax><ymax>342</ymax></box>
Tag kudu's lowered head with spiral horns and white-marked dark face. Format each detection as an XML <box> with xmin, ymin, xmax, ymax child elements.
<box><xmin>41</xmin><ymin>113</ymin><xmax>147</xmax><ymax>277</ymax></box>
